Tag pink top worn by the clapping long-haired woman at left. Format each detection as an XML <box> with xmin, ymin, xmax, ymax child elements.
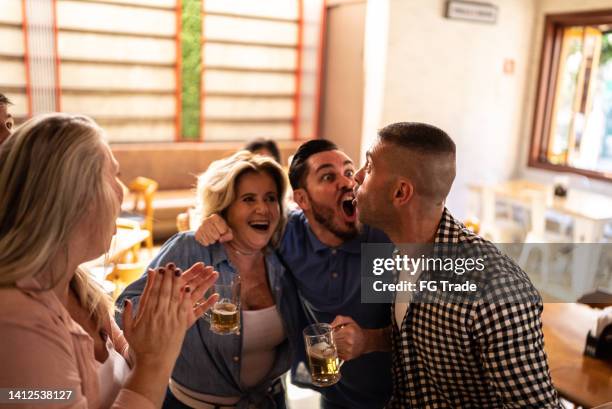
<box><xmin>0</xmin><ymin>278</ymin><xmax>155</xmax><ymax>409</ymax></box>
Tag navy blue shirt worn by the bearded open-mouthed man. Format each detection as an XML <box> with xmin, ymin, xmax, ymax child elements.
<box><xmin>279</xmin><ymin>211</ymin><xmax>392</xmax><ymax>409</ymax></box>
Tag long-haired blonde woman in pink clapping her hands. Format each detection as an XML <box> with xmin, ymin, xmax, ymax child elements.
<box><xmin>0</xmin><ymin>114</ymin><xmax>216</xmax><ymax>409</ymax></box>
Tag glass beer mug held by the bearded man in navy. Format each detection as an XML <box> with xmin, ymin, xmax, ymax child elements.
<box><xmin>304</xmin><ymin>323</ymin><xmax>344</xmax><ymax>386</ymax></box>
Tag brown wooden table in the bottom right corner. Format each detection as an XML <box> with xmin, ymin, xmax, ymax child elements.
<box><xmin>542</xmin><ymin>303</ymin><xmax>612</xmax><ymax>408</ymax></box>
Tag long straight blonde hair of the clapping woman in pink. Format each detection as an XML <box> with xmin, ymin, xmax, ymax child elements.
<box><xmin>0</xmin><ymin>113</ymin><xmax>118</xmax><ymax>326</ymax></box>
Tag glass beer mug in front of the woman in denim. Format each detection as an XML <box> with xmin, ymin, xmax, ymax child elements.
<box><xmin>204</xmin><ymin>278</ymin><xmax>240</xmax><ymax>335</ymax></box>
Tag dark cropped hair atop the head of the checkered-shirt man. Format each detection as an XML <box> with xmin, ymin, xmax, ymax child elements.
<box><xmin>378</xmin><ymin>122</ymin><xmax>456</xmax><ymax>154</ymax></box>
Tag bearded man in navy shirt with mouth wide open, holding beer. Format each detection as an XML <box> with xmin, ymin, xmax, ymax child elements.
<box><xmin>196</xmin><ymin>139</ymin><xmax>391</xmax><ymax>409</ymax></box>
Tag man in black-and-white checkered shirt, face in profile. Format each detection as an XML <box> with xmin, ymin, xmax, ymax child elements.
<box><xmin>355</xmin><ymin>122</ymin><xmax>560</xmax><ymax>408</ymax></box>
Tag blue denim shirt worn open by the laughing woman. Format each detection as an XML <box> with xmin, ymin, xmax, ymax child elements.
<box><xmin>117</xmin><ymin>232</ymin><xmax>303</xmax><ymax>408</ymax></box>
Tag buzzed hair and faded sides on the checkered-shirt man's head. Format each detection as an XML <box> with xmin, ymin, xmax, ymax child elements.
<box><xmin>378</xmin><ymin>122</ymin><xmax>456</xmax><ymax>204</ymax></box>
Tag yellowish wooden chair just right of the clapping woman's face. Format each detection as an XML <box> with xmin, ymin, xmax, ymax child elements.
<box><xmin>120</xmin><ymin>176</ymin><xmax>158</xmax><ymax>250</ymax></box>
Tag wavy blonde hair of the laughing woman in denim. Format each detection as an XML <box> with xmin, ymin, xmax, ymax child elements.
<box><xmin>196</xmin><ymin>151</ymin><xmax>288</xmax><ymax>245</ymax></box>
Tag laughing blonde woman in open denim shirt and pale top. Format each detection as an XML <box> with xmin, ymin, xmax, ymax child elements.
<box><xmin>118</xmin><ymin>151</ymin><xmax>301</xmax><ymax>409</ymax></box>
